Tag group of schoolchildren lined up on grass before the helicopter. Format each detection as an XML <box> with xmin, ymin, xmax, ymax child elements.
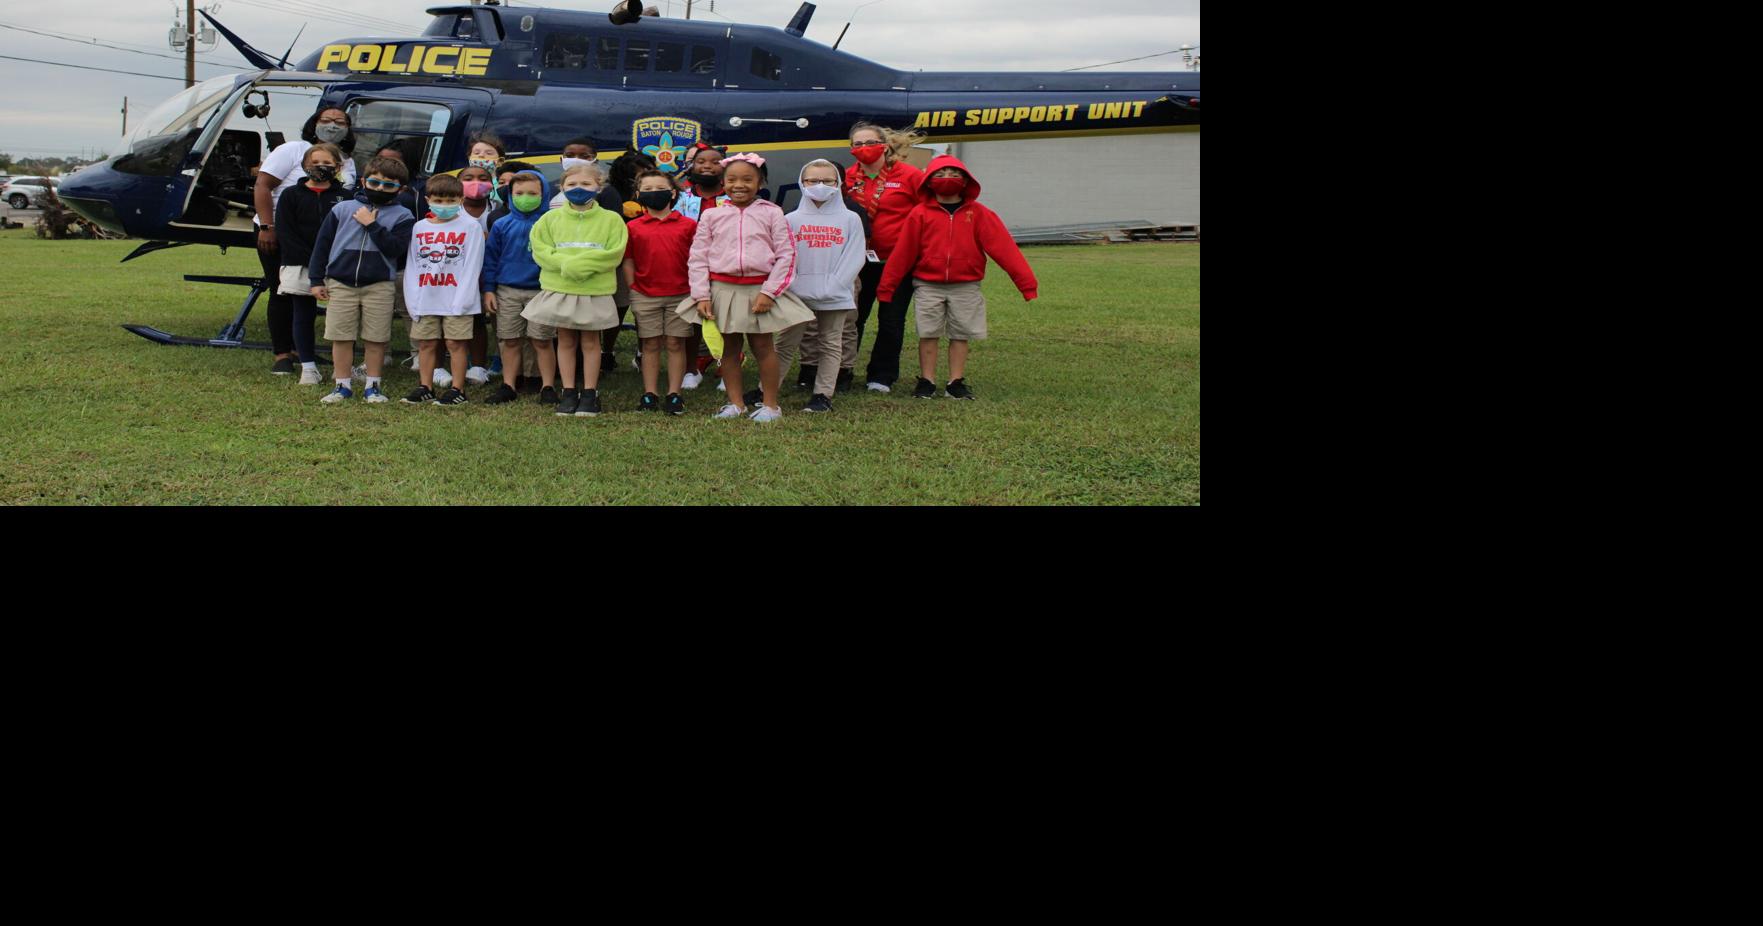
<box><xmin>275</xmin><ymin>123</ymin><xmax>1037</xmax><ymax>422</ymax></box>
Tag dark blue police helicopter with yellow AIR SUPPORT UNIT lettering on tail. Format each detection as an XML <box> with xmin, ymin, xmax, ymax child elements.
<box><xmin>58</xmin><ymin>0</ymin><xmax>1201</xmax><ymax>349</ymax></box>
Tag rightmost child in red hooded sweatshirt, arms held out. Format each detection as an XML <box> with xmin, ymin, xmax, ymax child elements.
<box><xmin>876</xmin><ymin>155</ymin><xmax>1040</xmax><ymax>399</ymax></box>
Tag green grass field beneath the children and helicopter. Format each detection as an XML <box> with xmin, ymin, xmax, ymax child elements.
<box><xmin>0</xmin><ymin>229</ymin><xmax>1201</xmax><ymax>504</ymax></box>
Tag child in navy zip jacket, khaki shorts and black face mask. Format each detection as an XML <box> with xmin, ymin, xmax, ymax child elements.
<box><xmin>307</xmin><ymin>157</ymin><xmax>416</xmax><ymax>404</ymax></box>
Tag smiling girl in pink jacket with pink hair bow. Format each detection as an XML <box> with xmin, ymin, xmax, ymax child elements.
<box><xmin>682</xmin><ymin>153</ymin><xmax>815</xmax><ymax>422</ymax></box>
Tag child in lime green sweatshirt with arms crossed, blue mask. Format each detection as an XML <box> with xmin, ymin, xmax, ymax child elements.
<box><xmin>520</xmin><ymin>164</ymin><xmax>629</xmax><ymax>418</ymax></box>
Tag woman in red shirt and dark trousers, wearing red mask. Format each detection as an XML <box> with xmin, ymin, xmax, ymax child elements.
<box><xmin>839</xmin><ymin>122</ymin><xmax>924</xmax><ymax>392</ymax></box>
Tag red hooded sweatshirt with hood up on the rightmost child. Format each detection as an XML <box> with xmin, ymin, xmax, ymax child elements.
<box><xmin>876</xmin><ymin>155</ymin><xmax>1040</xmax><ymax>302</ymax></box>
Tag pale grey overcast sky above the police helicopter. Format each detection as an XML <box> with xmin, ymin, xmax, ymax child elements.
<box><xmin>0</xmin><ymin>0</ymin><xmax>1201</xmax><ymax>157</ymax></box>
